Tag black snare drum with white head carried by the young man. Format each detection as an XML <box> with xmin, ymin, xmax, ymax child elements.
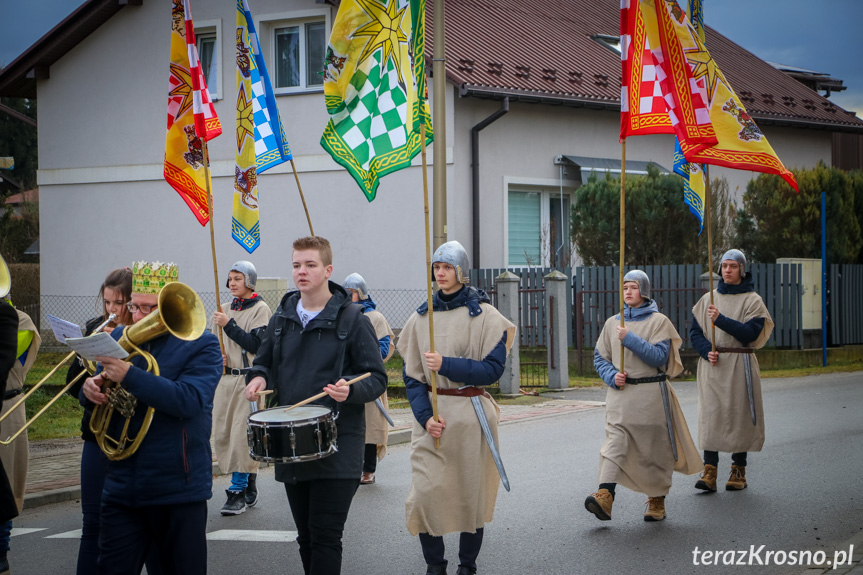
<box><xmin>248</xmin><ymin>405</ymin><xmax>338</xmax><ymax>463</ymax></box>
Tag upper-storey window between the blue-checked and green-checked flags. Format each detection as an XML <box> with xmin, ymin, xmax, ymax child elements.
<box><xmin>273</xmin><ymin>19</ymin><xmax>327</xmax><ymax>92</ymax></box>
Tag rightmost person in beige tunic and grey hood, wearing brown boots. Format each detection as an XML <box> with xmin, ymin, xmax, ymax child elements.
<box><xmin>689</xmin><ymin>250</ymin><xmax>773</xmax><ymax>492</ymax></box>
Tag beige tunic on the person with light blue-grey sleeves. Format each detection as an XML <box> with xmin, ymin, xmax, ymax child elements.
<box><xmin>596</xmin><ymin>312</ymin><xmax>703</xmax><ymax>497</ymax></box>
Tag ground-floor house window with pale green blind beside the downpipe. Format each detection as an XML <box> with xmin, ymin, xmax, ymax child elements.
<box><xmin>507</xmin><ymin>188</ymin><xmax>571</xmax><ymax>267</ymax></box>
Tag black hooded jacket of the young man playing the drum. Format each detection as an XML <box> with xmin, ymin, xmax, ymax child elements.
<box><xmin>246</xmin><ymin>282</ymin><xmax>387</xmax><ymax>484</ymax></box>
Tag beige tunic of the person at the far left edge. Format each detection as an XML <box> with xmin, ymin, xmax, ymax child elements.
<box><xmin>0</xmin><ymin>310</ymin><xmax>42</xmax><ymax>513</ymax></box>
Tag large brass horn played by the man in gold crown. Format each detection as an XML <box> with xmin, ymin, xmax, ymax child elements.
<box><xmin>90</xmin><ymin>282</ymin><xmax>207</xmax><ymax>461</ymax></box>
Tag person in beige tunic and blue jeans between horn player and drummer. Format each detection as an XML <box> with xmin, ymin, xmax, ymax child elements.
<box><xmin>213</xmin><ymin>261</ymin><xmax>272</xmax><ymax>515</ymax></box>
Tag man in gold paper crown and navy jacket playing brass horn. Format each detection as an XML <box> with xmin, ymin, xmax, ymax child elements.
<box><xmin>82</xmin><ymin>262</ymin><xmax>222</xmax><ymax>575</ymax></box>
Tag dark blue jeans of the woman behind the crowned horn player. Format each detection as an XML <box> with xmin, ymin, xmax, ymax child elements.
<box><xmin>77</xmin><ymin>441</ymin><xmax>162</xmax><ymax>575</ymax></box>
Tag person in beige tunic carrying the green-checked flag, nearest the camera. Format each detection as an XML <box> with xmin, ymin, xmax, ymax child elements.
<box><xmin>397</xmin><ymin>241</ymin><xmax>515</xmax><ymax>575</ymax></box>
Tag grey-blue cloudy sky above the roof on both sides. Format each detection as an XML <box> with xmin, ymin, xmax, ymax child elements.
<box><xmin>0</xmin><ymin>0</ymin><xmax>863</xmax><ymax>118</ymax></box>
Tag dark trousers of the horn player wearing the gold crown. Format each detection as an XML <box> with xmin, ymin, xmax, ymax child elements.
<box><xmin>98</xmin><ymin>501</ymin><xmax>207</xmax><ymax>575</ymax></box>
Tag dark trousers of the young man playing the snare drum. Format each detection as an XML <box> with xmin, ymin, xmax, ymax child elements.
<box><xmin>285</xmin><ymin>477</ymin><xmax>360</xmax><ymax>575</ymax></box>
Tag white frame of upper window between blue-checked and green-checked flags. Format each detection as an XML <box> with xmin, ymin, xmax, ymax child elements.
<box><xmin>257</xmin><ymin>8</ymin><xmax>332</xmax><ymax>96</ymax></box>
